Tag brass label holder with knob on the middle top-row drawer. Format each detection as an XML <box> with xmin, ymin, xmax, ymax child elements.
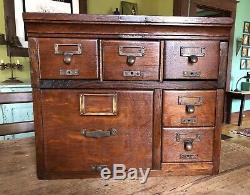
<box><xmin>119</xmin><ymin>46</ymin><xmax>145</xmax><ymax>66</ymax></box>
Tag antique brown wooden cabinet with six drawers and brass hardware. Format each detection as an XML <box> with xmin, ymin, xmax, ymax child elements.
<box><xmin>24</xmin><ymin>13</ymin><xmax>233</xmax><ymax>179</ymax></box>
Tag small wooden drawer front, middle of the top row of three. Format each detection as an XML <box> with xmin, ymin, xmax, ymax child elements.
<box><xmin>102</xmin><ymin>41</ymin><xmax>160</xmax><ymax>81</ymax></box>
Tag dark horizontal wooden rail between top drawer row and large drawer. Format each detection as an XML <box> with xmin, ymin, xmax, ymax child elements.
<box><xmin>40</xmin><ymin>80</ymin><xmax>218</xmax><ymax>89</ymax></box>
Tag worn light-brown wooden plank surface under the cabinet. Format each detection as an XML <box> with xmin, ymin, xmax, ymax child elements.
<box><xmin>0</xmin><ymin>121</ymin><xmax>250</xmax><ymax>195</ymax></box>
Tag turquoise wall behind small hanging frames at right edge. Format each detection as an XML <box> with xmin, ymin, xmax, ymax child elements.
<box><xmin>230</xmin><ymin>0</ymin><xmax>250</xmax><ymax>112</ymax></box>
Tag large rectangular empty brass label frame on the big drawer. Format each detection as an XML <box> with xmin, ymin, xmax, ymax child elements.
<box><xmin>80</xmin><ymin>94</ymin><xmax>117</xmax><ymax>116</ymax></box>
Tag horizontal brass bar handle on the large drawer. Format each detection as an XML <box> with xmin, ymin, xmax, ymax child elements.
<box><xmin>81</xmin><ymin>128</ymin><xmax>117</xmax><ymax>138</ymax></box>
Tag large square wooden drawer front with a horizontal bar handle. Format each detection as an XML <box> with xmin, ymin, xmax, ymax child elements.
<box><xmin>42</xmin><ymin>90</ymin><xmax>153</xmax><ymax>173</ymax></box>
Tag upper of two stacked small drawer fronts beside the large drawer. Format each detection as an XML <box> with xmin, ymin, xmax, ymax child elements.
<box><xmin>163</xmin><ymin>90</ymin><xmax>216</xmax><ymax>127</ymax></box>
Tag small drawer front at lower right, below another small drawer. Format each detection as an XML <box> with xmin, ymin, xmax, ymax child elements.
<box><xmin>162</xmin><ymin>127</ymin><xmax>214</xmax><ymax>162</ymax></box>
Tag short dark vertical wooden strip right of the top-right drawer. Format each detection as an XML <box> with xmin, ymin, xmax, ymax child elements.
<box><xmin>218</xmin><ymin>42</ymin><xmax>228</xmax><ymax>88</ymax></box>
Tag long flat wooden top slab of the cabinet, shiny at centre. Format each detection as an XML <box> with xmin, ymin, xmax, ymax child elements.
<box><xmin>23</xmin><ymin>13</ymin><xmax>233</xmax><ymax>26</ymax></box>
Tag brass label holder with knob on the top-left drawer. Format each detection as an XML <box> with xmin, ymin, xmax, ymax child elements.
<box><xmin>54</xmin><ymin>44</ymin><xmax>82</xmax><ymax>65</ymax></box>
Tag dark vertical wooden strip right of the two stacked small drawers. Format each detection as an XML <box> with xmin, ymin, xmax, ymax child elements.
<box><xmin>213</xmin><ymin>89</ymin><xmax>225</xmax><ymax>174</ymax></box>
